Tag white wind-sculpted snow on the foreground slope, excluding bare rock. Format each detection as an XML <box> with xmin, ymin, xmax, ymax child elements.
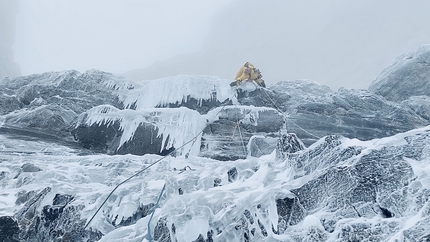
<box><xmin>0</xmin><ymin>122</ymin><xmax>430</xmax><ymax>241</ymax></box>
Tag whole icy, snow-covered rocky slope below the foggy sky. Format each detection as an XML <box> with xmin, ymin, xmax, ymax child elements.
<box><xmin>0</xmin><ymin>46</ymin><xmax>430</xmax><ymax>241</ymax></box>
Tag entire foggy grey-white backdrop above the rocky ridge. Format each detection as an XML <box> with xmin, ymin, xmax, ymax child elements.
<box><xmin>0</xmin><ymin>0</ymin><xmax>430</xmax><ymax>90</ymax></box>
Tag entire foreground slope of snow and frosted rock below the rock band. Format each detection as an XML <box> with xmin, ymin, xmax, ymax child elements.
<box><xmin>0</xmin><ymin>127</ymin><xmax>430</xmax><ymax>241</ymax></box>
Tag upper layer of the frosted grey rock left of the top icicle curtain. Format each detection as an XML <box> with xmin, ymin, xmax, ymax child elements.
<box><xmin>0</xmin><ymin>70</ymin><xmax>126</xmax><ymax>113</ymax></box>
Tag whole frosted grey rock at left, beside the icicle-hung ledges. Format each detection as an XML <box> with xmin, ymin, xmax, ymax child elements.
<box><xmin>0</xmin><ymin>70</ymin><xmax>127</xmax><ymax>142</ymax></box>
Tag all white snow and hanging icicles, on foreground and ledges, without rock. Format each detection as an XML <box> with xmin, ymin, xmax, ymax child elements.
<box><xmin>0</xmin><ymin>72</ymin><xmax>430</xmax><ymax>241</ymax></box>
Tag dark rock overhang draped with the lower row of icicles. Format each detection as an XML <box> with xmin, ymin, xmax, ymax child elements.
<box><xmin>72</xmin><ymin>106</ymin><xmax>206</xmax><ymax>155</ymax></box>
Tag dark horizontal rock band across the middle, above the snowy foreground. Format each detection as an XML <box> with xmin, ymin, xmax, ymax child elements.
<box><xmin>0</xmin><ymin>67</ymin><xmax>430</xmax><ymax>156</ymax></box>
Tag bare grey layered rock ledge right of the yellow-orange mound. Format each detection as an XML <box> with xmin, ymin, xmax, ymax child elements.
<box><xmin>233</xmin><ymin>81</ymin><xmax>429</xmax><ymax>146</ymax></box>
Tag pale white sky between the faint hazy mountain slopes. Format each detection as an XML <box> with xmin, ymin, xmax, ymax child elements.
<box><xmin>14</xmin><ymin>0</ymin><xmax>227</xmax><ymax>75</ymax></box>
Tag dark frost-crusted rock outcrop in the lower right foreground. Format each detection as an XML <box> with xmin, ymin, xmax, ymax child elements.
<box><xmin>278</xmin><ymin>130</ymin><xmax>429</xmax><ymax>241</ymax></box>
